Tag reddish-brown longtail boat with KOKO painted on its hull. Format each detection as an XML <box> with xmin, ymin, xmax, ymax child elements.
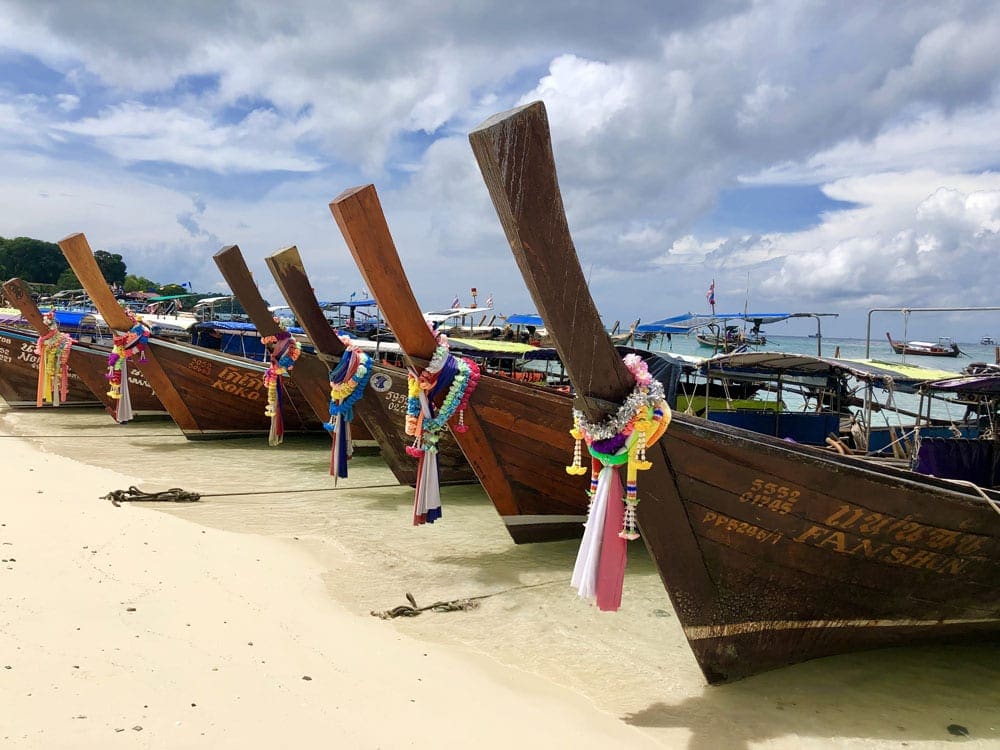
<box><xmin>59</xmin><ymin>234</ymin><xmax>322</xmax><ymax>439</ymax></box>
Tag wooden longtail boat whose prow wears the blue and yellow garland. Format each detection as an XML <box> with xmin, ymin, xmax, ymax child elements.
<box><xmin>266</xmin><ymin>247</ymin><xmax>475</xmax><ymax>485</ymax></box>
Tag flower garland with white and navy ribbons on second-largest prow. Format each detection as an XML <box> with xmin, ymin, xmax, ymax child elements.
<box><xmin>406</xmin><ymin>334</ymin><xmax>481</xmax><ymax>526</ymax></box>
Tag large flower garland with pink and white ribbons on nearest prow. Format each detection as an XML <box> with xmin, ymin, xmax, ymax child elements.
<box><xmin>566</xmin><ymin>354</ymin><xmax>671</xmax><ymax>610</ymax></box>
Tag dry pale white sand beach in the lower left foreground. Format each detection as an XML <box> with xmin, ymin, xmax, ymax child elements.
<box><xmin>0</xmin><ymin>432</ymin><xmax>654</xmax><ymax>748</ymax></box>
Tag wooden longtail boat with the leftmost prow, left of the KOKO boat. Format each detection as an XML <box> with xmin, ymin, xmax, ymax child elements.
<box><xmin>3</xmin><ymin>279</ymin><xmax>169</xmax><ymax>418</ymax></box>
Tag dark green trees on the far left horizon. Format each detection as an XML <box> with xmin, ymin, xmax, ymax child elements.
<box><xmin>0</xmin><ymin>237</ymin><xmax>178</xmax><ymax>294</ymax></box>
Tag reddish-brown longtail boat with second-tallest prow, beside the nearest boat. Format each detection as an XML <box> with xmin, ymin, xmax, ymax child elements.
<box><xmin>330</xmin><ymin>185</ymin><xmax>587</xmax><ymax>543</ymax></box>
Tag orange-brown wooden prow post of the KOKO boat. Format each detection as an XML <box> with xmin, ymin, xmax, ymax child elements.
<box><xmin>59</xmin><ymin>234</ymin><xmax>200</xmax><ymax>432</ymax></box>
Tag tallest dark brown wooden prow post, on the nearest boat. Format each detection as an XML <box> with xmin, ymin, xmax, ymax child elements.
<box><xmin>469</xmin><ymin>102</ymin><xmax>714</xmax><ymax>621</ymax></box>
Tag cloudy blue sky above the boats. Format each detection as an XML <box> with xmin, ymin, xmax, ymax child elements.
<box><xmin>0</xmin><ymin>0</ymin><xmax>1000</xmax><ymax>340</ymax></box>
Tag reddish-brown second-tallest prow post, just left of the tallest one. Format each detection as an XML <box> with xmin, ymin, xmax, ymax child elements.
<box><xmin>330</xmin><ymin>185</ymin><xmax>518</xmax><ymax>515</ymax></box>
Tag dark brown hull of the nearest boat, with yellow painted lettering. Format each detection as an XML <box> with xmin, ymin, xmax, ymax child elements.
<box><xmin>639</xmin><ymin>416</ymin><xmax>1000</xmax><ymax>683</ymax></box>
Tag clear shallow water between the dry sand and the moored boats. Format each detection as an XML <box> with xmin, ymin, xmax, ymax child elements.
<box><xmin>0</xmin><ymin>339</ymin><xmax>1000</xmax><ymax>750</ymax></box>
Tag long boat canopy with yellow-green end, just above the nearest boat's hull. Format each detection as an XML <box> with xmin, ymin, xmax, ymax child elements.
<box><xmin>702</xmin><ymin>352</ymin><xmax>957</xmax><ymax>391</ymax></box>
